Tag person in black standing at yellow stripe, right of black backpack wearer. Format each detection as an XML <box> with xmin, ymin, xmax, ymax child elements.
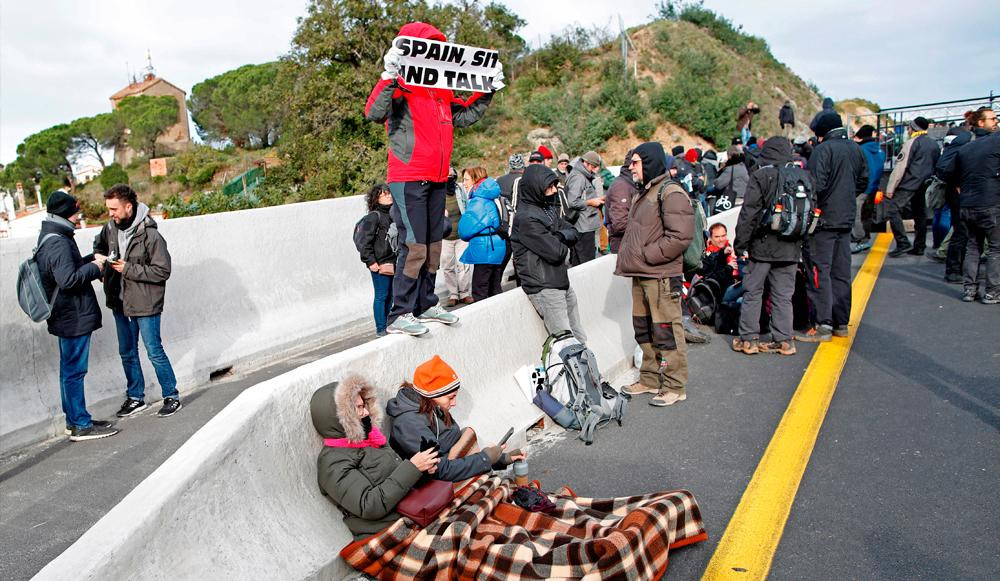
<box><xmin>795</xmin><ymin>113</ymin><xmax>868</xmax><ymax>342</ymax></box>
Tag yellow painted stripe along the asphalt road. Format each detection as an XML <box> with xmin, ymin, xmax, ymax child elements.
<box><xmin>702</xmin><ymin>233</ymin><xmax>892</xmax><ymax>581</ymax></box>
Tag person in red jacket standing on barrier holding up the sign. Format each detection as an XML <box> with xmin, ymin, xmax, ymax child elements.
<box><xmin>365</xmin><ymin>22</ymin><xmax>503</xmax><ymax>335</ymax></box>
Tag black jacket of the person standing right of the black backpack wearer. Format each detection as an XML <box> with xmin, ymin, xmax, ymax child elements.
<box><xmin>809</xmin><ymin>127</ymin><xmax>868</xmax><ymax>231</ymax></box>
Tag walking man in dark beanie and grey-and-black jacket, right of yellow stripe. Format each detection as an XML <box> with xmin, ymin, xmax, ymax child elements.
<box><xmin>885</xmin><ymin>117</ymin><xmax>941</xmax><ymax>257</ymax></box>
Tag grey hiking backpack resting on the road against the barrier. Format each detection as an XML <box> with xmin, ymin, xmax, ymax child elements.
<box><xmin>532</xmin><ymin>331</ymin><xmax>630</xmax><ymax>446</ymax></box>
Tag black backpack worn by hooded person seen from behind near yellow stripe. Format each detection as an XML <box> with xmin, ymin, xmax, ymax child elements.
<box><xmin>763</xmin><ymin>164</ymin><xmax>820</xmax><ymax>240</ymax></box>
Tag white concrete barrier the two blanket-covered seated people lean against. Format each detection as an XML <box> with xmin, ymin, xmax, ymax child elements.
<box><xmin>36</xmin><ymin>256</ymin><xmax>635</xmax><ymax>580</ymax></box>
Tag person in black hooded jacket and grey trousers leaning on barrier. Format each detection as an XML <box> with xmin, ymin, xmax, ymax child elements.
<box><xmin>510</xmin><ymin>165</ymin><xmax>587</xmax><ymax>343</ymax></box>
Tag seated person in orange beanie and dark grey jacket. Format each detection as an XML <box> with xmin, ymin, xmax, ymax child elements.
<box><xmin>386</xmin><ymin>354</ymin><xmax>524</xmax><ymax>482</ymax></box>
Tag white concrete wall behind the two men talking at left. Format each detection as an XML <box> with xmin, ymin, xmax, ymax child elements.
<box><xmin>0</xmin><ymin>196</ymin><xmax>386</xmax><ymax>454</ymax></box>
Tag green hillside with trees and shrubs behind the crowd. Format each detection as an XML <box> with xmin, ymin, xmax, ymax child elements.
<box><xmin>0</xmin><ymin>0</ymin><xmax>820</xmax><ymax>221</ymax></box>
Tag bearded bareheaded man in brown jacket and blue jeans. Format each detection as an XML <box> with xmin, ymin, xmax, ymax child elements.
<box><xmin>94</xmin><ymin>184</ymin><xmax>181</xmax><ymax>418</ymax></box>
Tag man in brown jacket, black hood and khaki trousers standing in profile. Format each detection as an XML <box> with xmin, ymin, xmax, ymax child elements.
<box><xmin>615</xmin><ymin>141</ymin><xmax>695</xmax><ymax>406</ymax></box>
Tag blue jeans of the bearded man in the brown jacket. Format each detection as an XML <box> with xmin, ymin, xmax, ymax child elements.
<box><xmin>112</xmin><ymin>310</ymin><xmax>177</xmax><ymax>401</ymax></box>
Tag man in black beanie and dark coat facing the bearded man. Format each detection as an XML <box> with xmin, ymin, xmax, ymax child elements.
<box><xmin>35</xmin><ymin>190</ymin><xmax>118</xmax><ymax>442</ymax></box>
